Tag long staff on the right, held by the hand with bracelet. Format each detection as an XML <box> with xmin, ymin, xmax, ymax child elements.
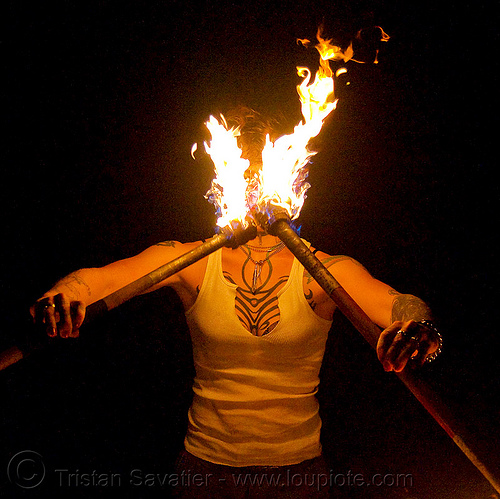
<box><xmin>268</xmin><ymin>211</ymin><xmax>500</xmax><ymax>492</ymax></box>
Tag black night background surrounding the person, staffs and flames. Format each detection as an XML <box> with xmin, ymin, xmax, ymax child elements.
<box><xmin>0</xmin><ymin>1</ymin><xmax>499</xmax><ymax>499</ymax></box>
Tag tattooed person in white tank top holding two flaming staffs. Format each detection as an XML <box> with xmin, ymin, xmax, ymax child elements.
<box><xmin>31</xmin><ymin>109</ymin><xmax>440</xmax><ymax>497</ymax></box>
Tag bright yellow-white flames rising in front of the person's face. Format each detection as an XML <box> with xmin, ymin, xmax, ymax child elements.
<box><xmin>205</xmin><ymin>29</ymin><xmax>382</xmax><ymax>227</ymax></box>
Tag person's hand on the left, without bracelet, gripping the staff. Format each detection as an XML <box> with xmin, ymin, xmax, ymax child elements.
<box><xmin>30</xmin><ymin>293</ymin><xmax>86</xmax><ymax>338</ymax></box>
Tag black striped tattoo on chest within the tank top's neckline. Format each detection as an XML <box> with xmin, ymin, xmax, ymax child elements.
<box><xmin>223</xmin><ymin>259</ymin><xmax>288</xmax><ymax>336</ymax></box>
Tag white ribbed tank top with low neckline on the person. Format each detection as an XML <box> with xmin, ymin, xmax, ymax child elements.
<box><xmin>185</xmin><ymin>246</ymin><xmax>331</xmax><ymax>466</ymax></box>
